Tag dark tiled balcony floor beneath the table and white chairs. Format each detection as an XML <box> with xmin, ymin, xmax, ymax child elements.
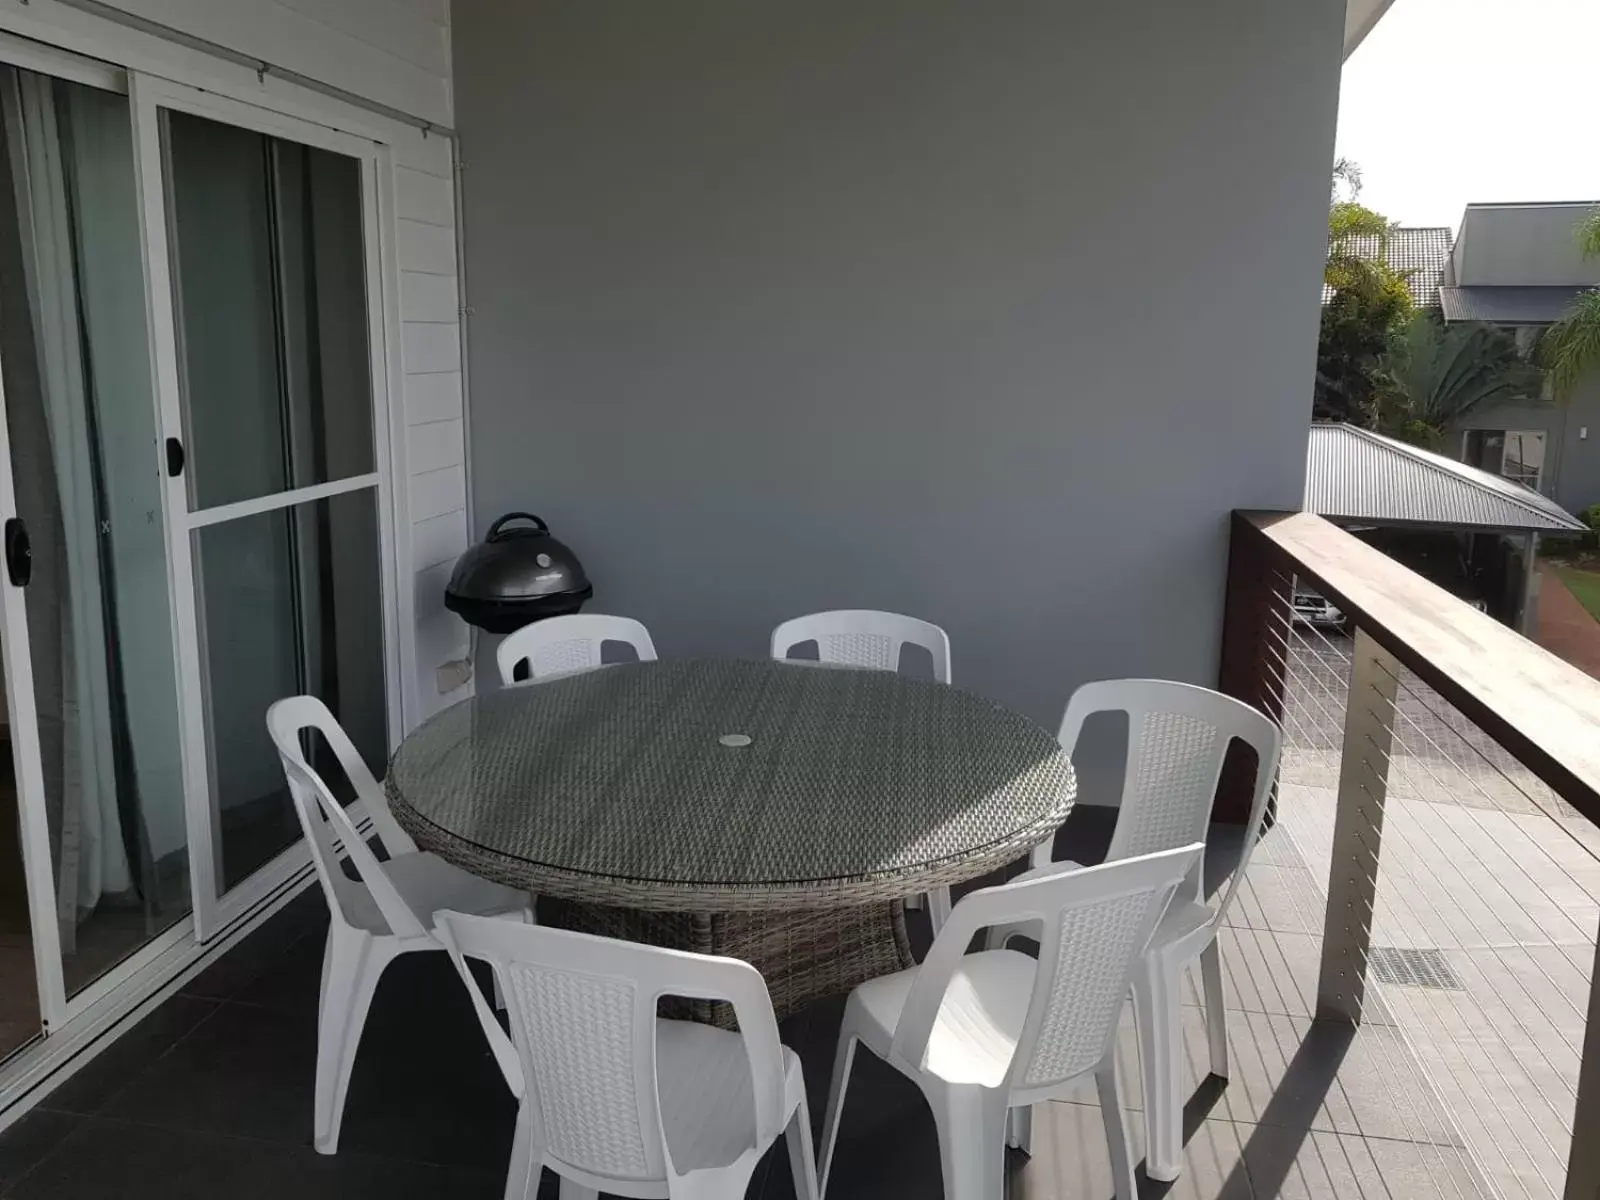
<box><xmin>0</xmin><ymin>808</ymin><xmax>1486</xmax><ymax>1200</ymax></box>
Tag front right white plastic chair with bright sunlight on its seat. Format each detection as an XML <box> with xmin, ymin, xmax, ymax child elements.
<box><xmin>822</xmin><ymin>845</ymin><xmax>1202</xmax><ymax>1200</ymax></box>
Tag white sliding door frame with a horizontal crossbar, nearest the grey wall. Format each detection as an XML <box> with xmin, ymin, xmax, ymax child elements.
<box><xmin>130</xmin><ymin>72</ymin><xmax>405</xmax><ymax>941</ymax></box>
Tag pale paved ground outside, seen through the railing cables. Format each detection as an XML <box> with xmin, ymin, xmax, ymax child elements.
<box><xmin>1280</xmin><ymin>633</ymin><xmax>1600</xmax><ymax>1200</ymax></box>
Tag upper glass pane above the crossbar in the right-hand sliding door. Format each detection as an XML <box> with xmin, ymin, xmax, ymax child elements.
<box><xmin>165</xmin><ymin>112</ymin><xmax>374</xmax><ymax>510</ymax></box>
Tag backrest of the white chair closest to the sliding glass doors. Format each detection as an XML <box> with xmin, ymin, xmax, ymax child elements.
<box><xmin>267</xmin><ymin>696</ymin><xmax>427</xmax><ymax>938</ymax></box>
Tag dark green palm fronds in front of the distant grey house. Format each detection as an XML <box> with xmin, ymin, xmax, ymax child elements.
<box><xmin>1378</xmin><ymin>312</ymin><xmax>1544</xmax><ymax>450</ymax></box>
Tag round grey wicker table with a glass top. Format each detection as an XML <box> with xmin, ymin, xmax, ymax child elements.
<box><xmin>384</xmin><ymin>659</ymin><xmax>1077</xmax><ymax>1018</ymax></box>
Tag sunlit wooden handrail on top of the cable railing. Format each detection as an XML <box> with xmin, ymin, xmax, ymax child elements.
<box><xmin>1234</xmin><ymin>512</ymin><xmax>1600</xmax><ymax>826</ymax></box>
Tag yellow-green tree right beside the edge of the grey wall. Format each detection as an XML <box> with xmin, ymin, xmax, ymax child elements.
<box><xmin>1312</xmin><ymin>190</ymin><xmax>1414</xmax><ymax>429</ymax></box>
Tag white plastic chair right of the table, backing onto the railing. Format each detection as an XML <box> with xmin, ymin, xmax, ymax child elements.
<box><xmin>990</xmin><ymin>680</ymin><xmax>1283</xmax><ymax>1181</ymax></box>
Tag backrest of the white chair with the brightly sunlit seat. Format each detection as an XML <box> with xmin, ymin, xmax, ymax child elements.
<box><xmin>890</xmin><ymin>843</ymin><xmax>1205</xmax><ymax>1102</ymax></box>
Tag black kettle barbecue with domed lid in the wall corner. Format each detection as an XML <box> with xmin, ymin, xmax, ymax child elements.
<box><xmin>445</xmin><ymin>512</ymin><xmax>595</xmax><ymax>634</ymax></box>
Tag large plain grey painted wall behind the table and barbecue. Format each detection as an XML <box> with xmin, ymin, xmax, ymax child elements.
<box><xmin>453</xmin><ymin>0</ymin><xmax>1344</xmax><ymax>739</ymax></box>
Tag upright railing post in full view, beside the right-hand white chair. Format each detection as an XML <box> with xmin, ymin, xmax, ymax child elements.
<box><xmin>1317</xmin><ymin>629</ymin><xmax>1400</xmax><ymax>1026</ymax></box>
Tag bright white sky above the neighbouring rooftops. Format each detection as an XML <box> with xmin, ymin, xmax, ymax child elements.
<box><xmin>1338</xmin><ymin>0</ymin><xmax>1600</xmax><ymax>229</ymax></box>
